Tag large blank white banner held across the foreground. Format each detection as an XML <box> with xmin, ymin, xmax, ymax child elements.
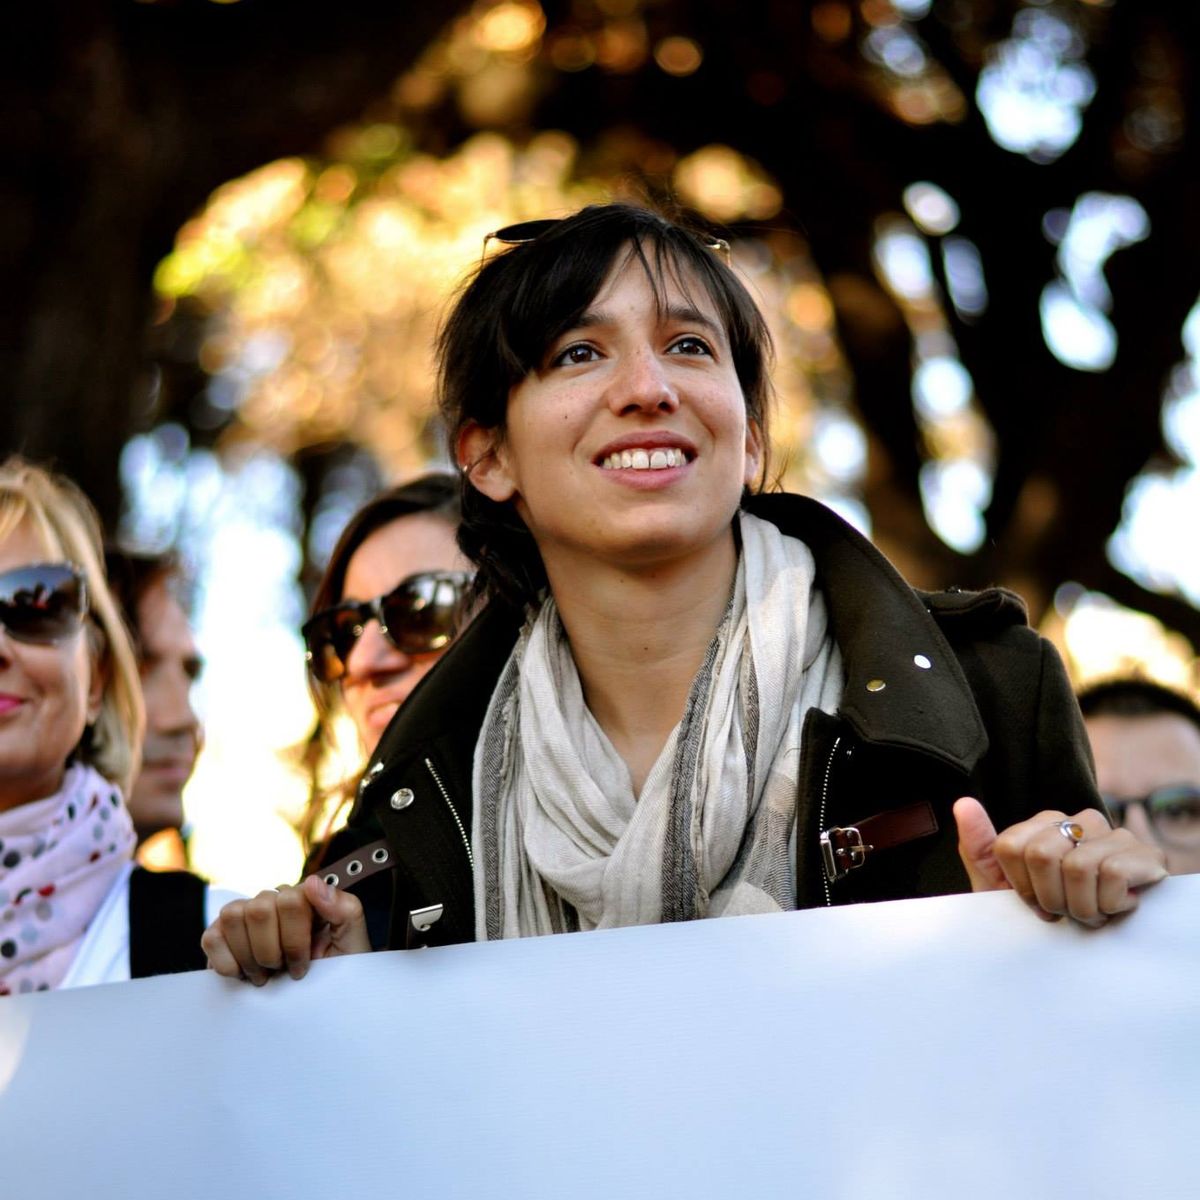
<box><xmin>0</xmin><ymin>876</ymin><xmax>1200</xmax><ymax>1200</ymax></box>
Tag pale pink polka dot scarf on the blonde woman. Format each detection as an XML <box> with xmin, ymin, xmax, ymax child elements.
<box><xmin>0</xmin><ymin>764</ymin><xmax>137</xmax><ymax>996</ymax></box>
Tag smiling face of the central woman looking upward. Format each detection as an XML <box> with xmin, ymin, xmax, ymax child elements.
<box><xmin>460</xmin><ymin>254</ymin><xmax>760</xmax><ymax>583</ymax></box>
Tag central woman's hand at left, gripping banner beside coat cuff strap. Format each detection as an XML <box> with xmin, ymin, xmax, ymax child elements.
<box><xmin>200</xmin><ymin>875</ymin><xmax>371</xmax><ymax>986</ymax></box>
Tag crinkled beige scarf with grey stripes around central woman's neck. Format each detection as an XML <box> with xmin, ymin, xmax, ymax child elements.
<box><xmin>474</xmin><ymin>514</ymin><xmax>844</xmax><ymax>940</ymax></box>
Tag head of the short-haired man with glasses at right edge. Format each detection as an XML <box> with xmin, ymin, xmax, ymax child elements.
<box><xmin>1079</xmin><ymin>679</ymin><xmax>1200</xmax><ymax>875</ymax></box>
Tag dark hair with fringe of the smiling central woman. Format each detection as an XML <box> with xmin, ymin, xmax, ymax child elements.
<box><xmin>438</xmin><ymin>204</ymin><xmax>772</xmax><ymax>607</ymax></box>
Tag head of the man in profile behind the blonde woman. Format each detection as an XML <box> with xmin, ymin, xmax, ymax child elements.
<box><xmin>106</xmin><ymin>550</ymin><xmax>203</xmax><ymax>841</ymax></box>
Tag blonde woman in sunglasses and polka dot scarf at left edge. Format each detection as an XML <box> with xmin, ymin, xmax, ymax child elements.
<box><xmin>0</xmin><ymin>458</ymin><xmax>233</xmax><ymax>996</ymax></box>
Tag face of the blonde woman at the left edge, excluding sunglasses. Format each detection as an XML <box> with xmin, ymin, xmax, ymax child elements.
<box><xmin>0</xmin><ymin>522</ymin><xmax>102</xmax><ymax>810</ymax></box>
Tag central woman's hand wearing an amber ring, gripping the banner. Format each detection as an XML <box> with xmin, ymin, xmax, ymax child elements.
<box><xmin>954</xmin><ymin>797</ymin><xmax>1166</xmax><ymax>928</ymax></box>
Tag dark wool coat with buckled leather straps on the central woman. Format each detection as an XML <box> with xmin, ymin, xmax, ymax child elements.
<box><xmin>325</xmin><ymin>494</ymin><xmax>1103</xmax><ymax>947</ymax></box>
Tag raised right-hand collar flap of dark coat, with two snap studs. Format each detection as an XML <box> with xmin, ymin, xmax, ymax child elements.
<box><xmin>745</xmin><ymin>493</ymin><xmax>988</xmax><ymax>772</ymax></box>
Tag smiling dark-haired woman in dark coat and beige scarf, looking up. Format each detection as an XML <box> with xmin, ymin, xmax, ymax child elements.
<box><xmin>204</xmin><ymin>205</ymin><xmax>1164</xmax><ymax>983</ymax></box>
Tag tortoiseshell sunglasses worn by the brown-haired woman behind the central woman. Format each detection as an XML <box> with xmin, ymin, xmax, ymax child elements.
<box><xmin>300</xmin><ymin>571</ymin><xmax>472</xmax><ymax>683</ymax></box>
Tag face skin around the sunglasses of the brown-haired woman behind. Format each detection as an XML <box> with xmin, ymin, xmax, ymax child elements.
<box><xmin>340</xmin><ymin>512</ymin><xmax>470</xmax><ymax>754</ymax></box>
